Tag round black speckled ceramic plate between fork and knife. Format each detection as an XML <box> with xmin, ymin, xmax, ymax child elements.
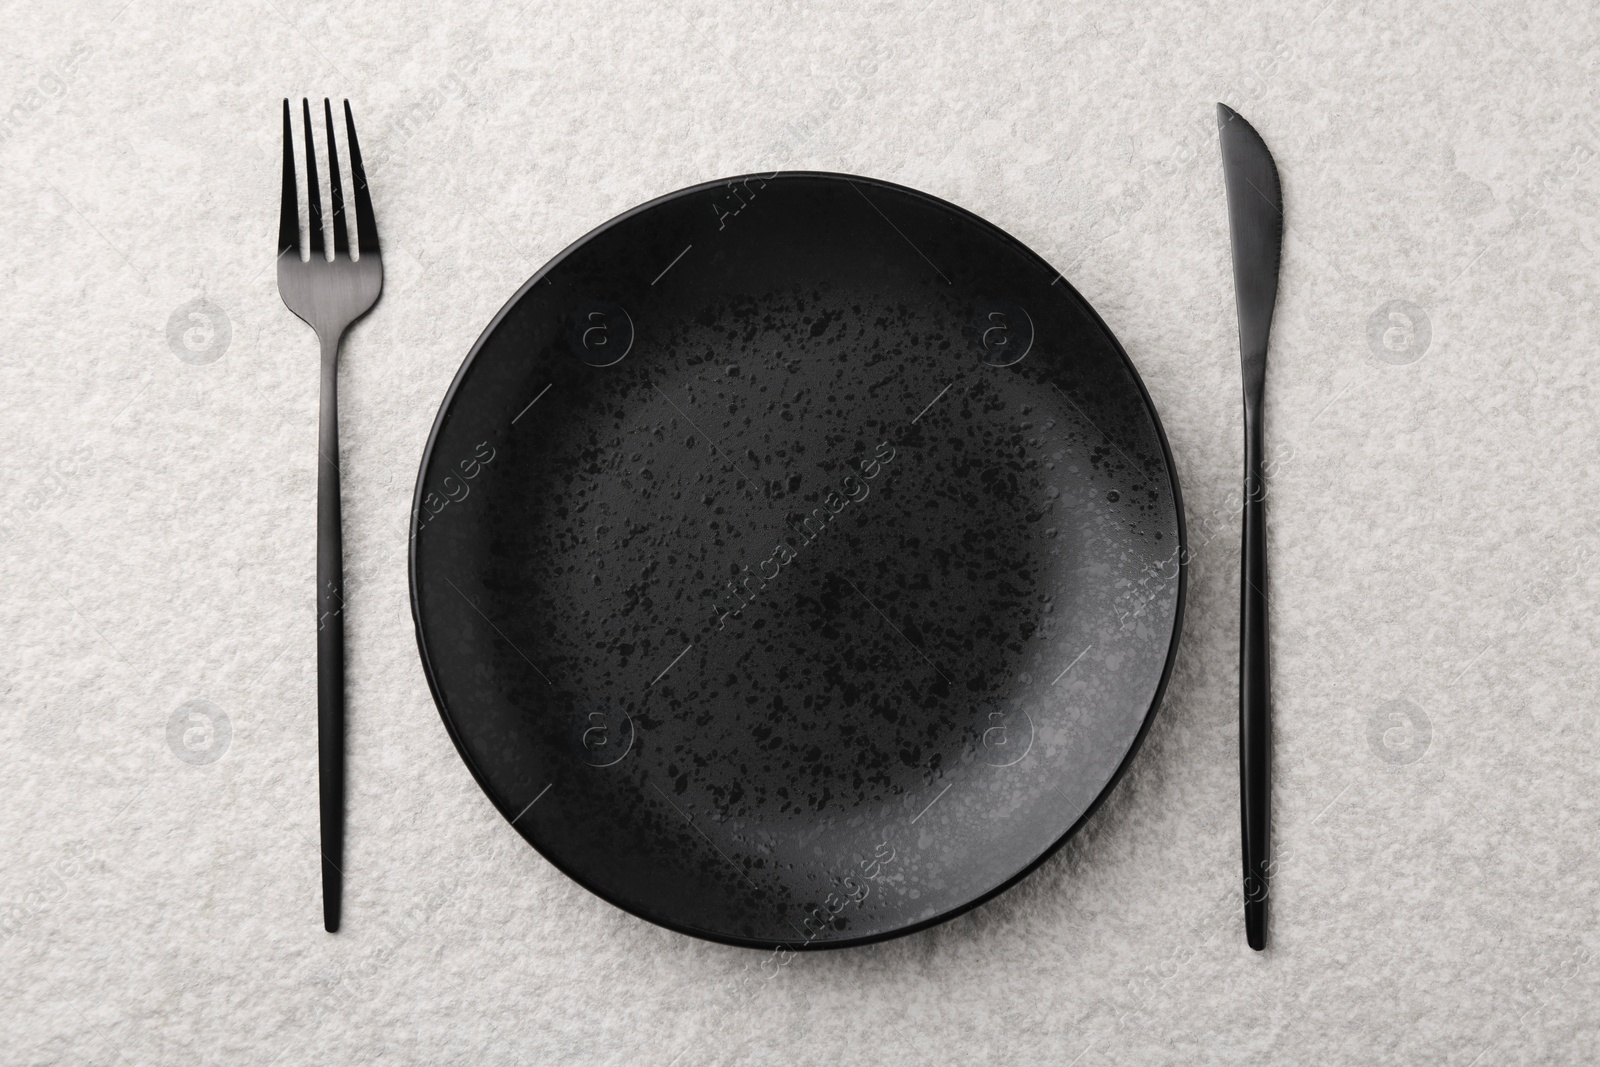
<box><xmin>411</xmin><ymin>173</ymin><xmax>1184</xmax><ymax>947</ymax></box>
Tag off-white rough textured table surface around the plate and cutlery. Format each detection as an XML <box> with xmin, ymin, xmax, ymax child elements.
<box><xmin>0</xmin><ymin>0</ymin><xmax>1600</xmax><ymax>1067</ymax></box>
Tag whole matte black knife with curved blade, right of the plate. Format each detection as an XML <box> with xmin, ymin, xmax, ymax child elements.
<box><xmin>1216</xmin><ymin>104</ymin><xmax>1283</xmax><ymax>950</ymax></box>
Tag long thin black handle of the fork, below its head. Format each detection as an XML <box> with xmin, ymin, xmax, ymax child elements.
<box><xmin>317</xmin><ymin>338</ymin><xmax>344</xmax><ymax>934</ymax></box>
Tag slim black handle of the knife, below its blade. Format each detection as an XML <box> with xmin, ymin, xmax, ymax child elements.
<box><xmin>1238</xmin><ymin>400</ymin><xmax>1272</xmax><ymax>950</ymax></box>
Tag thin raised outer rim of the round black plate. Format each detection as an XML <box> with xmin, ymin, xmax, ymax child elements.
<box><xmin>406</xmin><ymin>170</ymin><xmax>1189</xmax><ymax>952</ymax></box>
